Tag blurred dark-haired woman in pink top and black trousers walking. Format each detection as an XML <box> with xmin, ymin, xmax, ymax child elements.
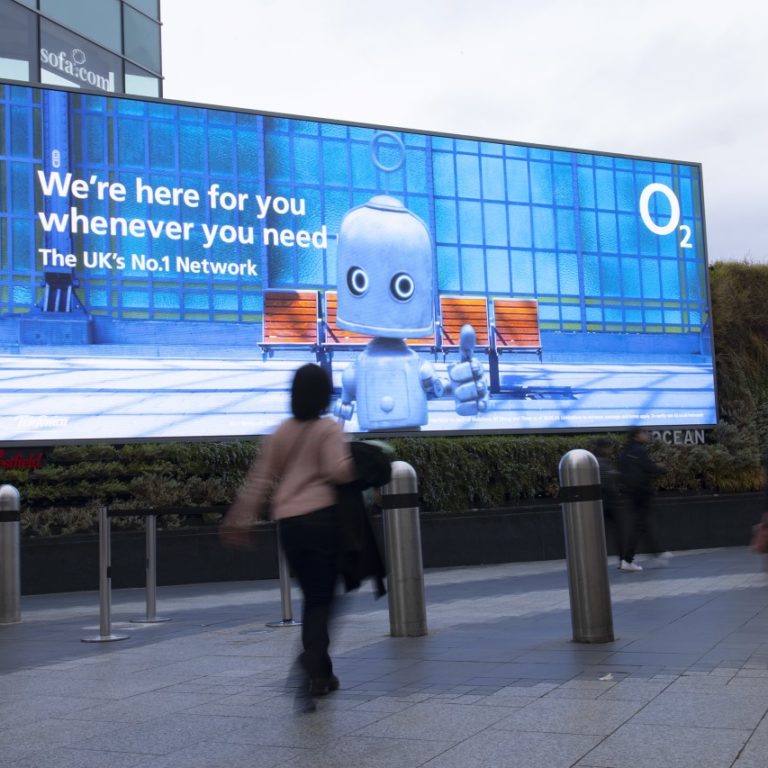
<box><xmin>224</xmin><ymin>364</ymin><xmax>356</xmax><ymax>709</ymax></box>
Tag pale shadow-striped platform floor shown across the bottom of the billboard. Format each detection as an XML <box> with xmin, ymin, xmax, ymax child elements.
<box><xmin>0</xmin><ymin>346</ymin><xmax>717</xmax><ymax>443</ymax></box>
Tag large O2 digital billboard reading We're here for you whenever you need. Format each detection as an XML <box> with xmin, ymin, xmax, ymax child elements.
<box><xmin>0</xmin><ymin>83</ymin><xmax>716</xmax><ymax>444</ymax></box>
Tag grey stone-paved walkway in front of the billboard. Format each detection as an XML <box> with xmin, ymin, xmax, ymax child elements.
<box><xmin>0</xmin><ymin>548</ymin><xmax>768</xmax><ymax>768</ymax></box>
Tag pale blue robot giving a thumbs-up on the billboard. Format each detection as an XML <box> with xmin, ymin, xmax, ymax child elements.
<box><xmin>334</xmin><ymin>195</ymin><xmax>488</xmax><ymax>430</ymax></box>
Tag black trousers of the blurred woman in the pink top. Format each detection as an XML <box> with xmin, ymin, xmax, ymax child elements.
<box><xmin>278</xmin><ymin>506</ymin><xmax>339</xmax><ymax>679</ymax></box>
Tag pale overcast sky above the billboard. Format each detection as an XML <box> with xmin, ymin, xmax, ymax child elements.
<box><xmin>161</xmin><ymin>0</ymin><xmax>768</xmax><ymax>263</ymax></box>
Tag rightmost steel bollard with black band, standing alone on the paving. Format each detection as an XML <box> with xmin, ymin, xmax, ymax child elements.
<box><xmin>559</xmin><ymin>448</ymin><xmax>614</xmax><ymax>643</ymax></box>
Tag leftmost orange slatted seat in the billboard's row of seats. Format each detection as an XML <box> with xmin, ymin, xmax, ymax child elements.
<box><xmin>259</xmin><ymin>289</ymin><xmax>321</xmax><ymax>360</ymax></box>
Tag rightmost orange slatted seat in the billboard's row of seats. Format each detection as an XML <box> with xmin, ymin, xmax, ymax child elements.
<box><xmin>490</xmin><ymin>298</ymin><xmax>542</xmax><ymax>392</ymax></box>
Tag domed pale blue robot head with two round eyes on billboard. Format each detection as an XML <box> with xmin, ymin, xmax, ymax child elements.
<box><xmin>336</xmin><ymin>195</ymin><xmax>434</xmax><ymax>339</ymax></box>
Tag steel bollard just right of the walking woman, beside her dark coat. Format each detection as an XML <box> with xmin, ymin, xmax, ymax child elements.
<box><xmin>381</xmin><ymin>461</ymin><xmax>427</xmax><ymax>637</ymax></box>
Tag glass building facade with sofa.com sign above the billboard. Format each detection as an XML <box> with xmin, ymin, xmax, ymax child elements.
<box><xmin>0</xmin><ymin>0</ymin><xmax>162</xmax><ymax>97</ymax></box>
